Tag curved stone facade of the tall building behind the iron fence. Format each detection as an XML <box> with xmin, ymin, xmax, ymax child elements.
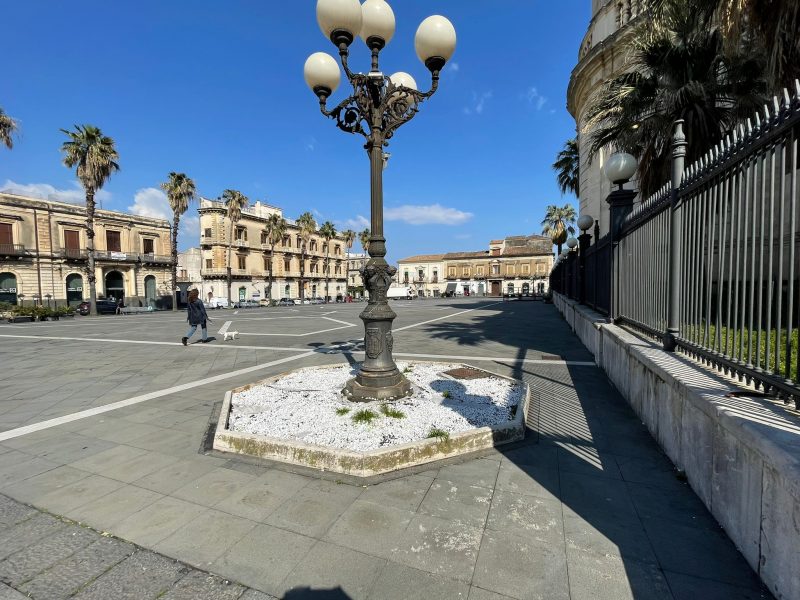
<box><xmin>567</xmin><ymin>0</ymin><xmax>644</xmax><ymax>235</ymax></box>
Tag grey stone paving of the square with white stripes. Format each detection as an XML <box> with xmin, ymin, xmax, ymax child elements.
<box><xmin>0</xmin><ymin>299</ymin><xmax>770</xmax><ymax>600</ymax></box>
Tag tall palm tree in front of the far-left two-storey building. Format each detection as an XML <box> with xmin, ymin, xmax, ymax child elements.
<box><xmin>61</xmin><ymin>125</ymin><xmax>119</xmax><ymax>316</ymax></box>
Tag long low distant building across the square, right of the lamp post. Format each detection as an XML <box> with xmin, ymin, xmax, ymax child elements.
<box><xmin>397</xmin><ymin>235</ymin><xmax>553</xmax><ymax>297</ymax></box>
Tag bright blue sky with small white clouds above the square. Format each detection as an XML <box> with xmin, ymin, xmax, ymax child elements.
<box><xmin>0</xmin><ymin>0</ymin><xmax>591</xmax><ymax>261</ymax></box>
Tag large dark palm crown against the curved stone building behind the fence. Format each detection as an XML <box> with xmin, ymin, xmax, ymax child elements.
<box><xmin>587</xmin><ymin>0</ymin><xmax>766</xmax><ymax>197</ymax></box>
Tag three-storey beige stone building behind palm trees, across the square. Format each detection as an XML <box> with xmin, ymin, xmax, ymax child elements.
<box><xmin>199</xmin><ymin>199</ymin><xmax>347</xmax><ymax>301</ymax></box>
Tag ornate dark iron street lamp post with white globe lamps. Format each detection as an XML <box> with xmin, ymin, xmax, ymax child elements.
<box><xmin>304</xmin><ymin>0</ymin><xmax>456</xmax><ymax>401</ymax></box>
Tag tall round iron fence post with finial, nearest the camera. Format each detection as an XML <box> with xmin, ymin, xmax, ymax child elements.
<box><xmin>664</xmin><ymin>119</ymin><xmax>688</xmax><ymax>352</ymax></box>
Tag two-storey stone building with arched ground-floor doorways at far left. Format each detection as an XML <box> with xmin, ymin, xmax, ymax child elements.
<box><xmin>0</xmin><ymin>193</ymin><xmax>172</xmax><ymax>308</ymax></box>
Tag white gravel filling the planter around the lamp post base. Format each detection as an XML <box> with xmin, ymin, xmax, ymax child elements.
<box><xmin>229</xmin><ymin>363</ymin><xmax>525</xmax><ymax>452</ymax></box>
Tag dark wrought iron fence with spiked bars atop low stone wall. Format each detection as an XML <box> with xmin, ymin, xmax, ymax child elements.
<box><xmin>551</xmin><ymin>82</ymin><xmax>800</xmax><ymax>406</ymax></box>
